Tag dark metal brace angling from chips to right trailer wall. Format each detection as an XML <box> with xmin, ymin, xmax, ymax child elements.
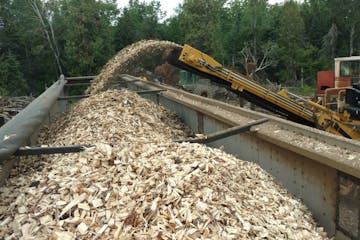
<box><xmin>175</xmin><ymin>118</ymin><xmax>269</xmax><ymax>143</ymax></box>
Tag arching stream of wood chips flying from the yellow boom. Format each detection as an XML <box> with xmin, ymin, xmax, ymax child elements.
<box><xmin>86</xmin><ymin>40</ymin><xmax>181</xmax><ymax>94</ymax></box>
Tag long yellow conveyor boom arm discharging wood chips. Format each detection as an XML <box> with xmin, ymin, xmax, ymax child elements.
<box><xmin>167</xmin><ymin>45</ymin><xmax>360</xmax><ymax>139</ymax></box>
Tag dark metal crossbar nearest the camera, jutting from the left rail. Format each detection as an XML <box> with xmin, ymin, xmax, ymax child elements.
<box><xmin>14</xmin><ymin>145</ymin><xmax>94</xmax><ymax>156</ymax></box>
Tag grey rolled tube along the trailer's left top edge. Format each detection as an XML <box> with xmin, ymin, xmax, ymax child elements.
<box><xmin>0</xmin><ymin>75</ymin><xmax>65</xmax><ymax>161</ymax></box>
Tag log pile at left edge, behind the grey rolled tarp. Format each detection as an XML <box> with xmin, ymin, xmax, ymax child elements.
<box><xmin>0</xmin><ymin>96</ymin><xmax>34</xmax><ymax>126</ymax></box>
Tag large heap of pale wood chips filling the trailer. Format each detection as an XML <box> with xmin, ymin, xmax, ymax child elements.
<box><xmin>0</xmin><ymin>90</ymin><xmax>326</xmax><ymax>240</ymax></box>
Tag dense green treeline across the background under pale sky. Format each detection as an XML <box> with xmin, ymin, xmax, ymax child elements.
<box><xmin>0</xmin><ymin>0</ymin><xmax>360</xmax><ymax>95</ymax></box>
